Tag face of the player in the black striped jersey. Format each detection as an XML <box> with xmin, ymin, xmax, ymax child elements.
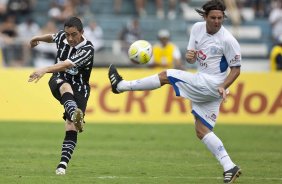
<box><xmin>65</xmin><ymin>27</ymin><xmax>83</xmax><ymax>47</ymax></box>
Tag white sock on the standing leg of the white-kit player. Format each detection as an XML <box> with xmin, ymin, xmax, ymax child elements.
<box><xmin>202</xmin><ymin>132</ymin><xmax>235</xmax><ymax>171</ymax></box>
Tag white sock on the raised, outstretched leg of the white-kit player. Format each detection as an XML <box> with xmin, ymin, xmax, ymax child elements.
<box><xmin>117</xmin><ymin>74</ymin><xmax>161</xmax><ymax>92</ymax></box>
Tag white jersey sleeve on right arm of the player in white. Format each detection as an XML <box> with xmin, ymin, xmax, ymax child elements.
<box><xmin>224</xmin><ymin>37</ymin><xmax>241</xmax><ymax>67</ymax></box>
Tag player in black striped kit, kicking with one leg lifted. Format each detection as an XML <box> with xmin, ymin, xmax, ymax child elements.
<box><xmin>28</xmin><ymin>17</ymin><xmax>94</xmax><ymax>175</ymax></box>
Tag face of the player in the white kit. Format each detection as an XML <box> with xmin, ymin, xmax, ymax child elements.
<box><xmin>205</xmin><ymin>10</ymin><xmax>224</xmax><ymax>34</ymax></box>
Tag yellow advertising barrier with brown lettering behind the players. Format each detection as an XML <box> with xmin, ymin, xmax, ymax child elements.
<box><xmin>0</xmin><ymin>69</ymin><xmax>282</xmax><ymax>124</ymax></box>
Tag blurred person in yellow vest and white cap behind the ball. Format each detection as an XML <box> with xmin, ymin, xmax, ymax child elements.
<box><xmin>150</xmin><ymin>29</ymin><xmax>185</xmax><ymax>69</ymax></box>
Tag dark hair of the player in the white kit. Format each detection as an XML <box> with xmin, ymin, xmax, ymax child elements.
<box><xmin>195</xmin><ymin>0</ymin><xmax>227</xmax><ymax>18</ymax></box>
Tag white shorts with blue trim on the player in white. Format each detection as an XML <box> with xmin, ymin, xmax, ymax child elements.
<box><xmin>167</xmin><ymin>69</ymin><xmax>222</xmax><ymax>130</ymax></box>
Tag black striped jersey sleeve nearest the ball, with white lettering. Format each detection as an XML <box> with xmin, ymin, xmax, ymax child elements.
<box><xmin>68</xmin><ymin>46</ymin><xmax>94</xmax><ymax>67</ymax></box>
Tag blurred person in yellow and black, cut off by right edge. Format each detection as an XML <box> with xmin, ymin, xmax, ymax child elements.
<box><xmin>270</xmin><ymin>35</ymin><xmax>282</xmax><ymax>71</ymax></box>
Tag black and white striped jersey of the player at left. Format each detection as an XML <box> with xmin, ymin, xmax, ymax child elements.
<box><xmin>53</xmin><ymin>30</ymin><xmax>94</xmax><ymax>96</ymax></box>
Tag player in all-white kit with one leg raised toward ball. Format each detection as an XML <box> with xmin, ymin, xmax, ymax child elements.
<box><xmin>108</xmin><ymin>0</ymin><xmax>241</xmax><ymax>183</ymax></box>
